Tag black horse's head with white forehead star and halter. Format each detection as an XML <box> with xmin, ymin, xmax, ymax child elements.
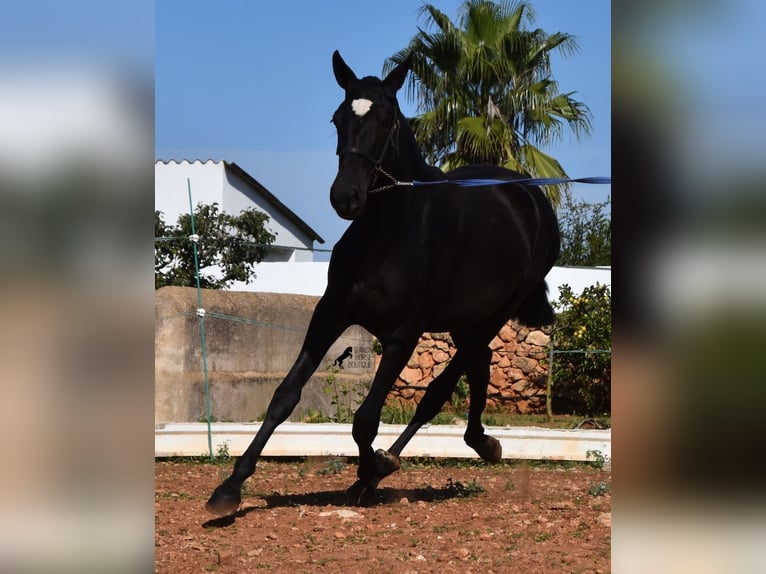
<box><xmin>330</xmin><ymin>51</ymin><xmax>409</xmax><ymax>219</ymax></box>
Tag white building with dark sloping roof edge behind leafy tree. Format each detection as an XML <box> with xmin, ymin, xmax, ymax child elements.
<box><xmin>154</xmin><ymin>160</ymin><xmax>324</xmax><ymax>262</ymax></box>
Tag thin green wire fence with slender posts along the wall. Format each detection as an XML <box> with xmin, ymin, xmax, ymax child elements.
<box><xmin>159</xmin><ymin>178</ymin><xmax>612</xmax><ymax>462</ymax></box>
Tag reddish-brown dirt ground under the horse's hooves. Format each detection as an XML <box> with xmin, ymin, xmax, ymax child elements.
<box><xmin>154</xmin><ymin>458</ymin><xmax>611</xmax><ymax>574</ymax></box>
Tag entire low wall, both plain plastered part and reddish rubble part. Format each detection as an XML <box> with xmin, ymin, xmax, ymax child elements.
<box><xmin>155</xmin><ymin>287</ymin><xmax>549</xmax><ymax>423</ymax></box>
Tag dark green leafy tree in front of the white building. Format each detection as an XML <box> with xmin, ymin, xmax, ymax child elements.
<box><xmin>154</xmin><ymin>203</ymin><xmax>276</xmax><ymax>289</ymax></box>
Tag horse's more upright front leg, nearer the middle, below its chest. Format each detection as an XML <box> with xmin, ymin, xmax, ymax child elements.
<box><xmin>348</xmin><ymin>333</ymin><xmax>420</xmax><ymax>504</ymax></box>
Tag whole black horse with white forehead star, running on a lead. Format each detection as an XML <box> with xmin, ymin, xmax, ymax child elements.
<box><xmin>206</xmin><ymin>52</ymin><xmax>559</xmax><ymax>515</ymax></box>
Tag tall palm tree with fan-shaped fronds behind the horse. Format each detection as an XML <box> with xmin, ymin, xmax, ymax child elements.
<box><xmin>384</xmin><ymin>0</ymin><xmax>591</xmax><ymax>206</ymax></box>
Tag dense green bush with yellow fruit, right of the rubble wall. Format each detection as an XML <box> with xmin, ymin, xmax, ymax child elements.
<box><xmin>549</xmin><ymin>284</ymin><xmax>612</xmax><ymax>417</ymax></box>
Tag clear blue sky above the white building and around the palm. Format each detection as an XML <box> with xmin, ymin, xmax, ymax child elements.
<box><xmin>155</xmin><ymin>0</ymin><xmax>611</xmax><ymax>258</ymax></box>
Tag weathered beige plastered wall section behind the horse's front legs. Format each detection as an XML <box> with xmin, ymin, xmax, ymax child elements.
<box><xmin>154</xmin><ymin>287</ymin><xmax>375</xmax><ymax>424</ymax></box>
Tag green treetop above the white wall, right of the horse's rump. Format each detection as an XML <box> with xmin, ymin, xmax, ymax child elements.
<box><xmin>557</xmin><ymin>194</ymin><xmax>612</xmax><ymax>267</ymax></box>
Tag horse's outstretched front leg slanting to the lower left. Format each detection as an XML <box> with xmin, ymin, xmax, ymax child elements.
<box><xmin>205</xmin><ymin>298</ymin><xmax>348</xmax><ymax>516</ymax></box>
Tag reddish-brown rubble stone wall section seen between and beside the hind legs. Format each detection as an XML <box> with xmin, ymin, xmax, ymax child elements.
<box><xmin>389</xmin><ymin>321</ymin><xmax>550</xmax><ymax>413</ymax></box>
